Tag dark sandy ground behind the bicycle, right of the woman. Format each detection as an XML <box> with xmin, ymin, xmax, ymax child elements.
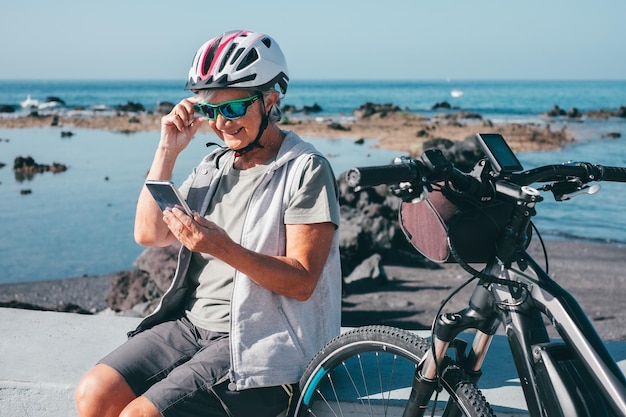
<box><xmin>343</xmin><ymin>239</ymin><xmax>626</xmax><ymax>340</ymax></box>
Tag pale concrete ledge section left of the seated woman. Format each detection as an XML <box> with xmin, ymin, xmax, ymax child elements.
<box><xmin>0</xmin><ymin>308</ymin><xmax>140</xmax><ymax>417</ymax></box>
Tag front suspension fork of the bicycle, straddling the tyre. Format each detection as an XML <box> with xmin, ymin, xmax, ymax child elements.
<box><xmin>403</xmin><ymin>283</ymin><xmax>500</xmax><ymax>417</ymax></box>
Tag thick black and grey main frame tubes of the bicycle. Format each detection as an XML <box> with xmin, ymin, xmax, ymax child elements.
<box><xmin>491</xmin><ymin>252</ymin><xmax>626</xmax><ymax>416</ymax></box>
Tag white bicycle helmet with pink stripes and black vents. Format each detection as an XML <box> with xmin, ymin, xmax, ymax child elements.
<box><xmin>185</xmin><ymin>30</ymin><xmax>289</xmax><ymax>94</ymax></box>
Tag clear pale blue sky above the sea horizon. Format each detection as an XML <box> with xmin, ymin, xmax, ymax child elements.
<box><xmin>0</xmin><ymin>0</ymin><xmax>626</xmax><ymax>80</ymax></box>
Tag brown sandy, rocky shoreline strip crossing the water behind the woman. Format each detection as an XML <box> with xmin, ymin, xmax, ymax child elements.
<box><xmin>0</xmin><ymin>103</ymin><xmax>580</xmax><ymax>155</ymax></box>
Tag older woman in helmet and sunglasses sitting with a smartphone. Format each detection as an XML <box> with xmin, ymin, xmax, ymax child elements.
<box><xmin>75</xmin><ymin>31</ymin><xmax>341</xmax><ymax>417</ymax></box>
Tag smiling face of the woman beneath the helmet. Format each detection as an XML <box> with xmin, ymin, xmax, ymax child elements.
<box><xmin>201</xmin><ymin>89</ymin><xmax>264</xmax><ymax>149</ymax></box>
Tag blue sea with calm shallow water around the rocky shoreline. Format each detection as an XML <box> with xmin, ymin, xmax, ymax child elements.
<box><xmin>0</xmin><ymin>80</ymin><xmax>626</xmax><ymax>283</ymax></box>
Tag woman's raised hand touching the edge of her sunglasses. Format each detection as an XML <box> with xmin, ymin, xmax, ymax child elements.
<box><xmin>159</xmin><ymin>96</ymin><xmax>206</xmax><ymax>155</ymax></box>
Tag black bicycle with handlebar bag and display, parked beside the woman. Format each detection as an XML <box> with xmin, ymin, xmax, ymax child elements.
<box><xmin>296</xmin><ymin>134</ymin><xmax>626</xmax><ymax>417</ymax></box>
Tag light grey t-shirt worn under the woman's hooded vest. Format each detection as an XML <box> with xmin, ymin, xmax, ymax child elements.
<box><xmin>181</xmin><ymin>154</ymin><xmax>339</xmax><ymax>332</ymax></box>
